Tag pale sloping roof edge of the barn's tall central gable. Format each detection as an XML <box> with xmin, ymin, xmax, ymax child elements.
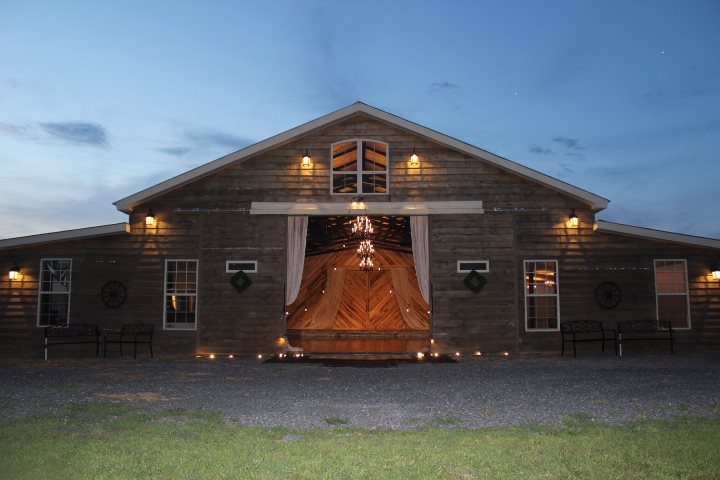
<box><xmin>114</xmin><ymin>102</ymin><xmax>609</xmax><ymax>213</ymax></box>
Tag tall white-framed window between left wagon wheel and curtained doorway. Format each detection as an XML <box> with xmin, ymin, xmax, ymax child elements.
<box><xmin>164</xmin><ymin>260</ymin><xmax>198</xmax><ymax>330</ymax></box>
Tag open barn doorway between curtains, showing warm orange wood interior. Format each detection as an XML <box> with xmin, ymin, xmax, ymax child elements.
<box><xmin>287</xmin><ymin>216</ymin><xmax>430</xmax><ymax>353</ymax></box>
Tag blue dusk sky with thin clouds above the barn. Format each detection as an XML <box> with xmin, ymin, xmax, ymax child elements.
<box><xmin>0</xmin><ymin>0</ymin><xmax>720</xmax><ymax>238</ymax></box>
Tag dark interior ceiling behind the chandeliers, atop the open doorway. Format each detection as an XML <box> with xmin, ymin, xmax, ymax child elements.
<box><xmin>305</xmin><ymin>215</ymin><xmax>412</xmax><ymax>256</ymax></box>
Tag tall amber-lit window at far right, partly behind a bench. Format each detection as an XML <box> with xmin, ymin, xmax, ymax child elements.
<box><xmin>655</xmin><ymin>260</ymin><xmax>690</xmax><ymax>328</ymax></box>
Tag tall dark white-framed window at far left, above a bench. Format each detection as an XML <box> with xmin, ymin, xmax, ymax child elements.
<box><xmin>37</xmin><ymin>258</ymin><xmax>72</xmax><ymax>327</ymax></box>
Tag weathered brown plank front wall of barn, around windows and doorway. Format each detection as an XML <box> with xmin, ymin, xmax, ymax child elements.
<box><xmin>0</xmin><ymin>111</ymin><xmax>720</xmax><ymax>352</ymax></box>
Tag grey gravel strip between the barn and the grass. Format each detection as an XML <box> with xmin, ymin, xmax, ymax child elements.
<box><xmin>0</xmin><ymin>354</ymin><xmax>720</xmax><ymax>429</ymax></box>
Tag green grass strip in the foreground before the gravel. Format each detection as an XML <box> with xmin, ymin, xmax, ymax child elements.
<box><xmin>0</xmin><ymin>404</ymin><xmax>720</xmax><ymax>480</ymax></box>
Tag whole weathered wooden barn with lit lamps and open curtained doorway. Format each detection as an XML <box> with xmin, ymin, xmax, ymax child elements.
<box><xmin>0</xmin><ymin>103</ymin><xmax>720</xmax><ymax>357</ymax></box>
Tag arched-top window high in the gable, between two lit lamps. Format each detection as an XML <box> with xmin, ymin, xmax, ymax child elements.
<box><xmin>331</xmin><ymin>140</ymin><xmax>388</xmax><ymax>194</ymax></box>
